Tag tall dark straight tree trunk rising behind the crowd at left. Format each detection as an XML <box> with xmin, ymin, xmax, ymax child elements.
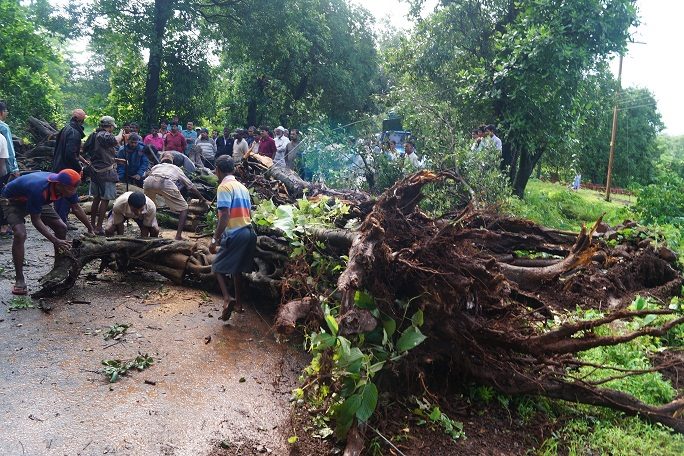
<box><xmin>143</xmin><ymin>0</ymin><xmax>173</xmax><ymax>127</ymax></box>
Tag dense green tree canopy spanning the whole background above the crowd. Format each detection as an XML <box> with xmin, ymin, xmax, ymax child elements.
<box><xmin>0</xmin><ymin>0</ymin><xmax>663</xmax><ymax>195</ymax></box>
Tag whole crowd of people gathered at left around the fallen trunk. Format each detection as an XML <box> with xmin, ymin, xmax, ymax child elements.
<box><xmin>0</xmin><ymin>102</ymin><xmax>262</xmax><ymax>320</ymax></box>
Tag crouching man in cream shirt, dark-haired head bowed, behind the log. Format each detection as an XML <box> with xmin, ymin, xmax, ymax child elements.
<box><xmin>105</xmin><ymin>192</ymin><xmax>159</xmax><ymax>238</ymax></box>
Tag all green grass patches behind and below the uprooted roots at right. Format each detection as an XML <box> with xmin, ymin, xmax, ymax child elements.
<box><xmin>508</xmin><ymin>180</ymin><xmax>684</xmax><ymax>456</ymax></box>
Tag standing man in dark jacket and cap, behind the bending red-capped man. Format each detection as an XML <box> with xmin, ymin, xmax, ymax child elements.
<box><xmin>52</xmin><ymin>109</ymin><xmax>86</xmax><ymax>226</ymax></box>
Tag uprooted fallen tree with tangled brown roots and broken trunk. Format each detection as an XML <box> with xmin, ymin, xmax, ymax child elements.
<box><xmin>32</xmin><ymin>156</ymin><xmax>684</xmax><ymax>446</ymax></box>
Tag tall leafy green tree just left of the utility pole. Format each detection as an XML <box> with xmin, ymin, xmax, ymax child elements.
<box><xmin>392</xmin><ymin>0</ymin><xmax>637</xmax><ymax>197</ymax></box>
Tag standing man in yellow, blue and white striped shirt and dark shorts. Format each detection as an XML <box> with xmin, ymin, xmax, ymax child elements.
<box><xmin>209</xmin><ymin>155</ymin><xmax>257</xmax><ymax>321</ymax></box>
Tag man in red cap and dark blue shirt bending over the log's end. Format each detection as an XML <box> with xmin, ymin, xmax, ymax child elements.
<box><xmin>0</xmin><ymin>169</ymin><xmax>93</xmax><ymax>295</ymax></box>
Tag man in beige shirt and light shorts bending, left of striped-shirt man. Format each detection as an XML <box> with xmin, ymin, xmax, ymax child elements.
<box><xmin>143</xmin><ymin>155</ymin><xmax>209</xmax><ymax>241</ymax></box>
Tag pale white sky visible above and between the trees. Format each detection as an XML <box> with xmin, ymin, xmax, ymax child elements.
<box><xmin>351</xmin><ymin>0</ymin><xmax>684</xmax><ymax>135</ymax></box>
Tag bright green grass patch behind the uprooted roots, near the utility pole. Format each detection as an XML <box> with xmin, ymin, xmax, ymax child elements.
<box><xmin>508</xmin><ymin>179</ymin><xmax>633</xmax><ymax>231</ymax></box>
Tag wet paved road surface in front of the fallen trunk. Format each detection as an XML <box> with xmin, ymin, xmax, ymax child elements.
<box><xmin>0</xmin><ymin>227</ymin><xmax>305</xmax><ymax>456</ymax></box>
